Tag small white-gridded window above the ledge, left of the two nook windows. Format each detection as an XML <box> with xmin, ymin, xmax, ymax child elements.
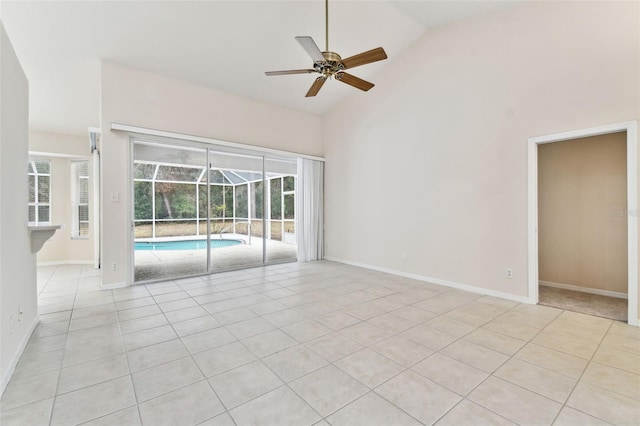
<box><xmin>28</xmin><ymin>160</ymin><xmax>51</xmax><ymax>223</ymax></box>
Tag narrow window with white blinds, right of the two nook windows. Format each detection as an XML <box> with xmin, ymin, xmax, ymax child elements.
<box><xmin>71</xmin><ymin>160</ymin><xmax>89</xmax><ymax>238</ymax></box>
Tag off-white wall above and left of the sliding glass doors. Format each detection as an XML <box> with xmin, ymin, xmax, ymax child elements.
<box><xmin>100</xmin><ymin>62</ymin><xmax>322</xmax><ymax>286</ymax></box>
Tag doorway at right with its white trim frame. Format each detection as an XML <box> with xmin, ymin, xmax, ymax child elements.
<box><xmin>529</xmin><ymin>122</ymin><xmax>638</xmax><ymax>325</ymax></box>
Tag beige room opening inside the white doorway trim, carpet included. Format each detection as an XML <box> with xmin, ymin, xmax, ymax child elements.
<box><xmin>538</xmin><ymin>132</ymin><xmax>628</xmax><ymax>322</ymax></box>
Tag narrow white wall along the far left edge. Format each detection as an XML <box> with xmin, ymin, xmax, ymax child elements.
<box><xmin>0</xmin><ymin>21</ymin><xmax>38</xmax><ymax>392</ymax></box>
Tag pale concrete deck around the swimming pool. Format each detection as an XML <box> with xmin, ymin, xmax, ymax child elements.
<box><xmin>134</xmin><ymin>234</ymin><xmax>297</xmax><ymax>282</ymax></box>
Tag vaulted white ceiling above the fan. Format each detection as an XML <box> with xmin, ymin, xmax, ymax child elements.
<box><xmin>1</xmin><ymin>0</ymin><xmax>519</xmax><ymax>135</ymax></box>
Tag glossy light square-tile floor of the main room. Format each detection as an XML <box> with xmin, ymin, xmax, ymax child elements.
<box><xmin>0</xmin><ymin>262</ymin><xmax>640</xmax><ymax>426</ymax></box>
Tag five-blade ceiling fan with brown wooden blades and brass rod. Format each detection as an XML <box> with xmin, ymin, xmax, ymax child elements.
<box><xmin>265</xmin><ymin>0</ymin><xmax>387</xmax><ymax>98</ymax></box>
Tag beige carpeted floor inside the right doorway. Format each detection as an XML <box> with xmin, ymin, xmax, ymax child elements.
<box><xmin>538</xmin><ymin>285</ymin><xmax>627</xmax><ymax>322</ymax></box>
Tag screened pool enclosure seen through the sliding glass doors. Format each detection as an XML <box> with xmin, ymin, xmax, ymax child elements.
<box><xmin>133</xmin><ymin>141</ymin><xmax>297</xmax><ymax>281</ymax></box>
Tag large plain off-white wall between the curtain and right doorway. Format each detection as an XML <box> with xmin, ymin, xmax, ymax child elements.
<box><xmin>323</xmin><ymin>2</ymin><xmax>640</xmax><ymax>298</ymax></box>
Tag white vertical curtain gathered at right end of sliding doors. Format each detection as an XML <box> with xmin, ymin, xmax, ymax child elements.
<box><xmin>296</xmin><ymin>158</ymin><xmax>324</xmax><ymax>262</ymax></box>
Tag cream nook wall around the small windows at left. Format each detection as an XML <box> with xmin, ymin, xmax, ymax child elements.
<box><xmin>29</xmin><ymin>131</ymin><xmax>95</xmax><ymax>265</ymax></box>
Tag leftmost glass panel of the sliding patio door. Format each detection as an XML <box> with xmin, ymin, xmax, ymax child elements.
<box><xmin>133</xmin><ymin>142</ymin><xmax>208</xmax><ymax>281</ymax></box>
